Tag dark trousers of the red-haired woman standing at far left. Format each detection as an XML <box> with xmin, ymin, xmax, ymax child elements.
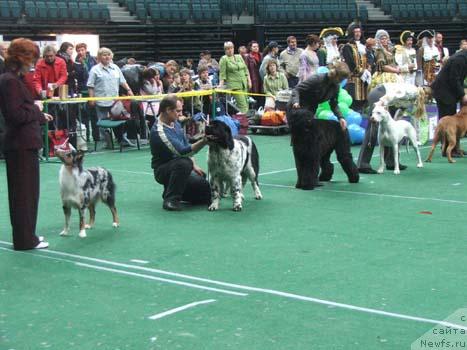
<box><xmin>5</xmin><ymin>150</ymin><xmax>39</xmax><ymax>250</ymax></box>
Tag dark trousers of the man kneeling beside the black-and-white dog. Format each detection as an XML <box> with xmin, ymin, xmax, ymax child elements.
<box><xmin>154</xmin><ymin>157</ymin><xmax>211</xmax><ymax>204</ymax></box>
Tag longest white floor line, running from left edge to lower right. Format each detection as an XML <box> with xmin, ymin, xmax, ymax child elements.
<box><xmin>0</xmin><ymin>241</ymin><xmax>467</xmax><ymax>330</ymax></box>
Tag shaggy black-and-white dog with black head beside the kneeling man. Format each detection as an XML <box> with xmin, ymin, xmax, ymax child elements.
<box><xmin>206</xmin><ymin>120</ymin><xmax>262</xmax><ymax>211</ymax></box>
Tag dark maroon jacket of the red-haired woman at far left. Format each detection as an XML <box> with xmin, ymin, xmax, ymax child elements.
<box><xmin>0</xmin><ymin>72</ymin><xmax>46</xmax><ymax>152</ymax></box>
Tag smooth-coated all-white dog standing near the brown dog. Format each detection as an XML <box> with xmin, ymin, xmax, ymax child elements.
<box><xmin>371</xmin><ymin>101</ymin><xmax>423</xmax><ymax>175</ymax></box>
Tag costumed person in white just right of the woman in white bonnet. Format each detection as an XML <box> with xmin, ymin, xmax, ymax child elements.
<box><xmin>395</xmin><ymin>30</ymin><xmax>417</xmax><ymax>85</ymax></box>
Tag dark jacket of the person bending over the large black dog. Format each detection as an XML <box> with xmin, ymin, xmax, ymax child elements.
<box><xmin>289</xmin><ymin>74</ymin><xmax>342</xmax><ymax>119</ymax></box>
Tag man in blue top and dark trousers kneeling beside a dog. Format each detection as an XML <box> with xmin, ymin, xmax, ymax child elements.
<box><xmin>150</xmin><ymin>95</ymin><xmax>211</xmax><ymax>210</ymax></box>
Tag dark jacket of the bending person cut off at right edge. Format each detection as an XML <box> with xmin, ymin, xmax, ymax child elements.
<box><xmin>431</xmin><ymin>50</ymin><xmax>467</xmax><ymax>104</ymax></box>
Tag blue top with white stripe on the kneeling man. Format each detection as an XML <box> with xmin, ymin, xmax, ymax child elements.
<box><xmin>150</xmin><ymin>120</ymin><xmax>191</xmax><ymax>169</ymax></box>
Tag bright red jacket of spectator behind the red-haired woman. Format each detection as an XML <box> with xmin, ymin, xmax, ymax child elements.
<box><xmin>34</xmin><ymin>57</ymin><xmax>68</xmax><ymax>97</ymax></box>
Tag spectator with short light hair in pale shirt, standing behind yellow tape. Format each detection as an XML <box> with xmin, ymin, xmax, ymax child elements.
<box><xmin>87</xmin><ymin>47</ymin><xmax>133</xmax><ymax>148</ymax></box>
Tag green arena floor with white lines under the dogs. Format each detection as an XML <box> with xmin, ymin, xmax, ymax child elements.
<box><xmin>0</xmin><ymin>135</ymin><xmax>467</xmax><ymax>350</ymax></box>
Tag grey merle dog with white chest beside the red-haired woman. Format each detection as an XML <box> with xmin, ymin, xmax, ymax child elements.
<box><xmin>55</xmin><ymin>143</ymin><xmax>119</xmax><ymax>238</ymax></box>
